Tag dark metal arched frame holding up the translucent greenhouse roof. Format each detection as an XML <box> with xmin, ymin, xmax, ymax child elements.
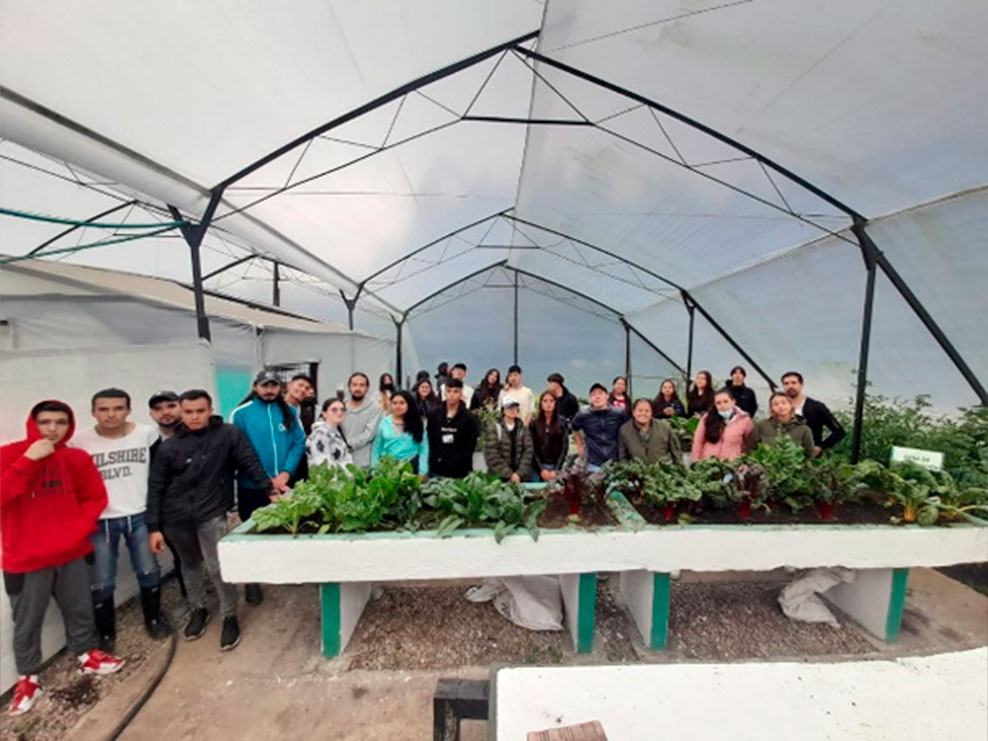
<box><xmin>0</xmin><ymin>30</ymin><xmax>988</xmax><ymax>450</ymax></box>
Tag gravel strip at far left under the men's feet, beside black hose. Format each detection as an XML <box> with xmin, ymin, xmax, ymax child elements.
<box><xmin>0</xmin><ymin>579</ymin><xmax>180</xmax><ymax>741</ymax></box>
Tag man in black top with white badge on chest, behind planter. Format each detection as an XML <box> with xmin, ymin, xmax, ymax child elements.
<box><xmin>426</xmin><ymin>378</ymin><xmax>480</xmax><ymax>479</ymax></box>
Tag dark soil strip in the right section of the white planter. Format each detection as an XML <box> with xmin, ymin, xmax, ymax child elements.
<box><xmin>632</xmin><ymin>502</ymin><xmax>893</xmax><ymax>525</ymax></box>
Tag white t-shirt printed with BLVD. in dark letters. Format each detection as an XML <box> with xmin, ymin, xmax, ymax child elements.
<box><xmin>72</xmin><ymin>424</ymin><xmax>158</xmax><ymax>520</ymax></box>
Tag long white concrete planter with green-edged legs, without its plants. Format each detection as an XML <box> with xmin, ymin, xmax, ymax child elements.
<box><xmin>219</xmin><ymin>497</ymin><xmax>988</xmax><ymax>654</ymax></box>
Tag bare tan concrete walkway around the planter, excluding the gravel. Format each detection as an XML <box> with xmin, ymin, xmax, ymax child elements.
<box><xmin>67</xmin><ymin>569</ymin><xmax>988</xmax><ymax>741</ymax></box>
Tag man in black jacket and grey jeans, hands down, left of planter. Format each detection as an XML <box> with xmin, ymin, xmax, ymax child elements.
<box><xmin>146</xmin><ymin>389</ymin><xmax>275</xmax><ymax>651</ymax></box>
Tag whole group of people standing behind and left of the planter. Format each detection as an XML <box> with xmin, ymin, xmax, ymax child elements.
<box><xmin>0</xmin><ymin>363</ymin><xmax>844</xmax><ymax>714</ymax></box>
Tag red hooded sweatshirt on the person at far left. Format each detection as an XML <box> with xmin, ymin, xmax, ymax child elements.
<box><xmin>0</xmin><ymin>402</ymin><xmax>107</xmax><ymax>574</ymax></box>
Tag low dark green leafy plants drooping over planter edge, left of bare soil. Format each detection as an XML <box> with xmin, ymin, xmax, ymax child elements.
<box><xmin>422</xmin><ymin>472</ymin><xmax>546</xmax><ymax>543</ymax></box>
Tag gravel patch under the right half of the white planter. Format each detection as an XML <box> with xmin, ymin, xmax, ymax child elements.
<box><xmin>669</xmin><ymin>581</ymin><xmax>875</xmax><ymax>661</ymax></box>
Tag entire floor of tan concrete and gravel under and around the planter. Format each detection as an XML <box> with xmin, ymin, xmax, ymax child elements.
<box><xmin>0</xmin><ymin>569</ymin><xmax>988</xmax><ymax>741</ymax></box>
